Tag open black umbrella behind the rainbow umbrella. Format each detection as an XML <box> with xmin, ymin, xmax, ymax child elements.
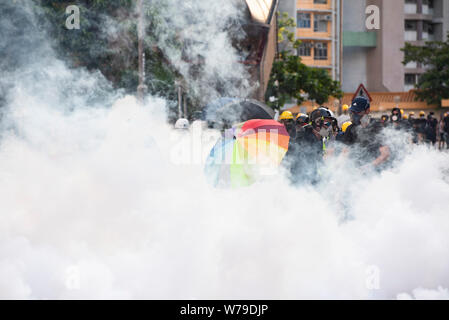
<box><xmin>203</xmin><ymin>98</ymin><xmax>274</xmax><ymax>129</ymax></box>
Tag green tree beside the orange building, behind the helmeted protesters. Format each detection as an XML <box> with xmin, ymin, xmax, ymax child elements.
<box><xmin>265</xmin><ymin>13</ymin><xmax>343</xmax><ymax>108</ymax></box>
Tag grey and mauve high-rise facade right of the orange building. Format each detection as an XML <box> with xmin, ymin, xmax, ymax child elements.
<box><xmin>342</xmin><ymin>0</ymin><xmax>449</xmax><ymax>92</ymax></box>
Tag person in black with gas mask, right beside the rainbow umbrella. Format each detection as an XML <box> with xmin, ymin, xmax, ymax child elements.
<box><xmin>284</xmin><ymin>107</ymin><xmax>335</xmax><ymax>185</ymax></box>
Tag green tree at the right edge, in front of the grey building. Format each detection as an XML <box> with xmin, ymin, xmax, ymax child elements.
<box><xmin>401</xmin><ymin>33</ymin><xmax>449</xmax><ymax>106</ymax></box>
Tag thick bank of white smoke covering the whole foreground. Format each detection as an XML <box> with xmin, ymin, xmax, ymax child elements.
<box><xmin>0</xmin><ymin>0</ymin><xmax>449</xmax><ymax>299</ymax></box>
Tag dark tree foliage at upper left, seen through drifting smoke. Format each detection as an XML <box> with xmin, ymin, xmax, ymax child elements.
<box><xmin>33</xmin><ymin>0</ymin><xmax>178</xmax><ymax>101</ymax></box>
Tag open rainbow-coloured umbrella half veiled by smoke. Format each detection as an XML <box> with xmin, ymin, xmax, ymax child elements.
<box><xmin>205</xmin><ymin>119</ymin><xmax>290</xmax><ymax>188</ymax></box>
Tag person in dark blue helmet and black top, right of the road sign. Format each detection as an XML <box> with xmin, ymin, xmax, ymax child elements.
<box><xmin>344</xmin><ymin>97</ymin><xmax>390</xmax><ymax>172</ymax></box>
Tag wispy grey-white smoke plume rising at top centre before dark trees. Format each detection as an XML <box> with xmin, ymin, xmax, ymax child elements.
<box><xmin>145</xmin><ymin>0</ymin><xmax>256</xmax><ymax>103</ymax></box>
